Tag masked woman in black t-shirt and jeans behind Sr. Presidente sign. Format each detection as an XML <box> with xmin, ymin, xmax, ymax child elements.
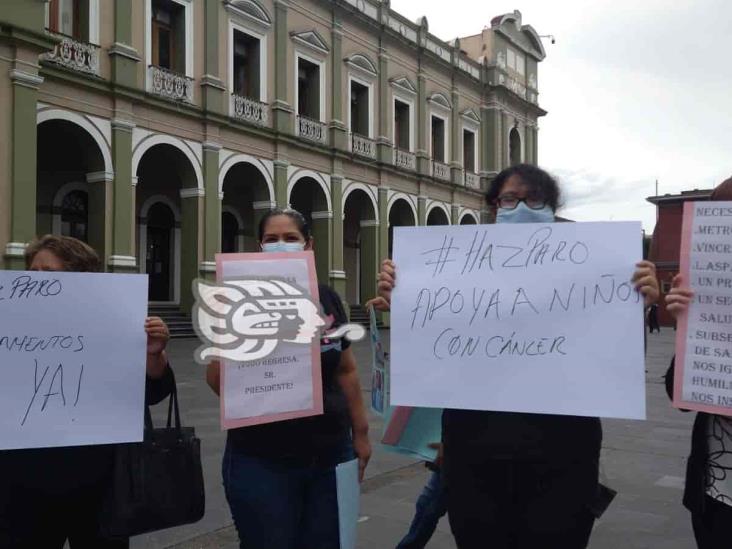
<box><xmin>207</xmin><ymin>209</ymin><xmax>371</xmax><ymax>549</ymax></box>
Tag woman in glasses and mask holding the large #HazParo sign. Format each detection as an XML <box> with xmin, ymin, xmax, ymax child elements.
<box><xmin>374</xmin><ymin>165</ymin><xmax>658</xmax><ymax>549</ymax></box>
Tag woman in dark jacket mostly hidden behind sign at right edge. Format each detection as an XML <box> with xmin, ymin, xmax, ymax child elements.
<box><xmin>666</xmin><ymin>178</ymin><xmax>732</xmax><ymax>549</ymax></box>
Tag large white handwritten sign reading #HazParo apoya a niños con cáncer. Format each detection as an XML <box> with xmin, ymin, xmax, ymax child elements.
<box><xmin>390</xmin><ymin>223</ymin><xmax>645</xmax><ymax>419</ymax></box>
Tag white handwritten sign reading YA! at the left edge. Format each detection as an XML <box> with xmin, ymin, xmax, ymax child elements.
<box><xmin>0</xmin><ymin>271</ymin><xmax>147</xmax><ymax>449</ymax></box>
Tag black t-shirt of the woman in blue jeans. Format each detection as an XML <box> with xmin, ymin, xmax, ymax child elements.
<box><xmin>228</xmin><ymin>285</ymin><xmax>350</xmax><ymax>463</ymax></box>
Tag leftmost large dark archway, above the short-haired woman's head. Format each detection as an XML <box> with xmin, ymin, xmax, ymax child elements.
<box><xmin>36</xmin><ymin>119</ymin><xmax>111</xmax><ymax>256</ymax></box>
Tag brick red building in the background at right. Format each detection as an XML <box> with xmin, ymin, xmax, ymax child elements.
<box><xmin>646</xmin><ymin>189</ymin><xmax>712</xmax><ymax>326</ymax></box>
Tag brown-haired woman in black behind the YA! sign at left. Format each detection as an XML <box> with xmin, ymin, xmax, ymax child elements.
<box><xmin>0</xmin><ymin>235</ymin><xmax>173</xmax><ymax>549</ymax></box>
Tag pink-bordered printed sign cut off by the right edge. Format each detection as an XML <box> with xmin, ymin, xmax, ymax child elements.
<box><xmin>674</xmin><ymin>202</ymin><xmax>732</xmax><ymax>416</ymax></box>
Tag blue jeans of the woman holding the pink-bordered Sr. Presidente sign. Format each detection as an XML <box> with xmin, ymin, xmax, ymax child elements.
<box><xmin>222</xmin><ymin>440</ymin><xmax>354</xmax><ymax>549</ymax></box>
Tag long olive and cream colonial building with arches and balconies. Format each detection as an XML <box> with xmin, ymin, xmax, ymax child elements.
<box><xmin>0</xmin><ymin>0</ymin><xmax>545</xmax><ymax>307</ymax></box>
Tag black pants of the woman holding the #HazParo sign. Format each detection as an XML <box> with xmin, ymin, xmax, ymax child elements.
<box><xmin>445</xmin><ymin>450</ymin><xmax>598</xmax><ymax>549</ymax></box>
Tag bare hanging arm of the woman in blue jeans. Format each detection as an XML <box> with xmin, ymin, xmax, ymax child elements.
<box><xmin>338</xmin><ymin>348</ymin><xmax>371</xmax><ymax>482</ymax></box>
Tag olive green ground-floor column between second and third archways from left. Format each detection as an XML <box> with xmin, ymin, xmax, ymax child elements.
<box><xmin>200</xmin><ymin>142</ymin><xmax>224</xmax><ymax>280</ymax></box>
